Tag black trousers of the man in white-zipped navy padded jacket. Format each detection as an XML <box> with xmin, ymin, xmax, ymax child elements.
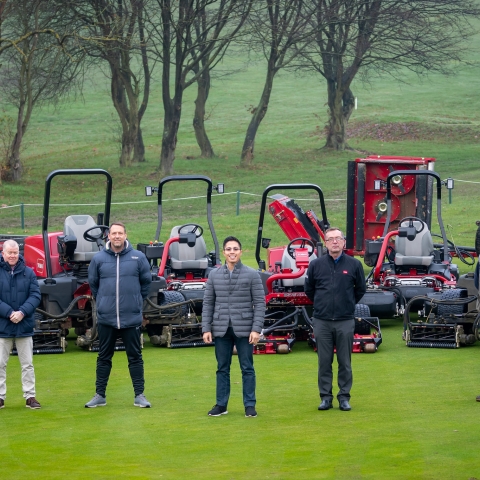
<box><xmin>96</xmin><ymin>324</ymin><xmax>145</xmax><ymax>397</ymax></box>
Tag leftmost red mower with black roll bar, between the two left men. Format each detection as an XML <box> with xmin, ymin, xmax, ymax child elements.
<box><xmin>20</xmin><ymin>169</ymin><xmax>165</xmax><ymax>353</ymax></box>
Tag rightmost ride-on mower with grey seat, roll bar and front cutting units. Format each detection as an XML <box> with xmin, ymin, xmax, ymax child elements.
<box><xmin>364</xmin><ymin>170</ymin><xmax>477</xmax><ymax>348</ymax></box>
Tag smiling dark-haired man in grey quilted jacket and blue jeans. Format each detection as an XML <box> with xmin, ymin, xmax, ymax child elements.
<box><xmin>202</xmin><ymin>236</ymin><xmax>265</xmax><ymax>417</ymax></box>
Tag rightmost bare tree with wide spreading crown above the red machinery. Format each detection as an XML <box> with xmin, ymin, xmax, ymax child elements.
<box><xmin>296</xmin><ymin>0</ymin><xmax>479</xmax><ymax>150</ymax></box>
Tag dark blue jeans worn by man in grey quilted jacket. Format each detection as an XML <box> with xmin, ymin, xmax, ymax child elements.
<box><xmin>215</xmin><ymin>327</ymin><xmax>256</xmax><ymax>408</ymax></box>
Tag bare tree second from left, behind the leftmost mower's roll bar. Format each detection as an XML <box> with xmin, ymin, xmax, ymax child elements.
<box><xmin>69</xmin><ymin>0</ymin><xmax>152</xmax><ymax>167</ymax></box>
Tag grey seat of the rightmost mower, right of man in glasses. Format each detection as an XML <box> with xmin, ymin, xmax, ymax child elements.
<box><xmin>395</xmin><ymin>220</ymin><xmax>434</xmax><ymax>267</ymax></box>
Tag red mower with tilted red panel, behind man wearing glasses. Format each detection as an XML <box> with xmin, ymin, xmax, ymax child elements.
<box><xmin>254</xmin><ymin>184</ymin><xmax>381</xmax><ymax>354</ymax></box>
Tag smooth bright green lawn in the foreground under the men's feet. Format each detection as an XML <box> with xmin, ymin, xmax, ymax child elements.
<box><xmin>0</xmin><ymin>320</ymin><xmax>480</xmax><ymax>480</ymax></box>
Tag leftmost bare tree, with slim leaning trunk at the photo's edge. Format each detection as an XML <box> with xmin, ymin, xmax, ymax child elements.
<box><xmin>0</xmin><ymin>0</ymin><xmax>80</xmax><ymax>181</ymax></box>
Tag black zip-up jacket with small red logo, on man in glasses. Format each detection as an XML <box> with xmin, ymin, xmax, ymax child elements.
<box><xmin>305</xmin><ymin>253</ymin><xmax>366</xmax><ymax>320</ymax></box>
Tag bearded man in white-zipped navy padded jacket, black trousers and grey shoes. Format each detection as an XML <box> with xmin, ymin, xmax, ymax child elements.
<box><xmin>85</xmin><ymin>222</ymin><xmax>152</xmax><ymax>408</ymax></box>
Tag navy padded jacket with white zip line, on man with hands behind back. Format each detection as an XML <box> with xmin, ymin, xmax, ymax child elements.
<box><xmin>88</xmin><ymin>242</ymin><xmax>152</xmax><ymax>329</ymax></box>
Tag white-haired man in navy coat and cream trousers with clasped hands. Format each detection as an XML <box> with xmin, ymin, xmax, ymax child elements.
<box><xmin>0</xmin><ymin>240</ymin><xmax>41</xmax><ymax>409</ymax></box>
